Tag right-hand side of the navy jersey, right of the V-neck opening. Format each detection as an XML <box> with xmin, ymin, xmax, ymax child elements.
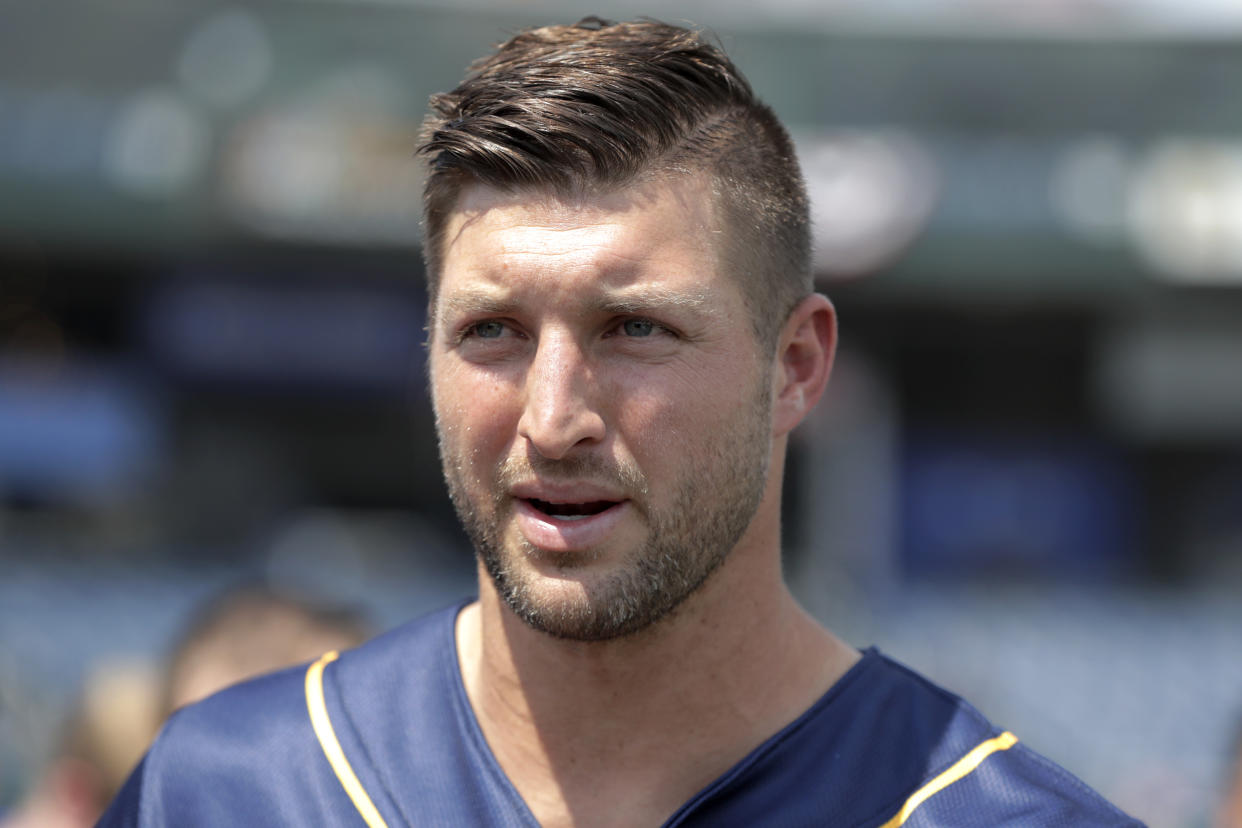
<box><xmin>686</xmin><ymin>650</ymin><xmax>1139</xmax><ymax>828</ymax></box>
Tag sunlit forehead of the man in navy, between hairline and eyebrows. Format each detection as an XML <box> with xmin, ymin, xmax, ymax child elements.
<box><xmin>440</xmin><ymin>176</ymin><xmax>720</xmax><ymax>302</ymax></box>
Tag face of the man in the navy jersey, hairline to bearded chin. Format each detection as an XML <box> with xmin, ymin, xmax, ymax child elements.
<box><xmin>430</xmin><ymin>178</ymin><xmax>773</xmax><ymax>641</ymax></box>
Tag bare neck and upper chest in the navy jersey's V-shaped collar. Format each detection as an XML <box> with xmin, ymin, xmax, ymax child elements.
<box><xmin>457</xmin><ymin>486</ymin><xmax>857</xmax><ymax>826</ymax></box>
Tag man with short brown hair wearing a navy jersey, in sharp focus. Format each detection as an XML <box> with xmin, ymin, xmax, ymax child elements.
<box><xmin>104</xmin><ymin>19</ymin><xmax>1133</xmax><ymax>827</ymax></box>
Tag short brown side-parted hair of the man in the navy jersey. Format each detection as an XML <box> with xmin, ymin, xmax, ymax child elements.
<box><xmin>420</xmin><ymin>17</ymin><xmax>812</xmax><ymax>346</ymax></box>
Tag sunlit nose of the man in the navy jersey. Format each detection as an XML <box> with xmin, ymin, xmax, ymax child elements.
<box><xmin>518</xmin><ymin>335</ymin><xmax>605</xmax><ymax>459</ymax></box>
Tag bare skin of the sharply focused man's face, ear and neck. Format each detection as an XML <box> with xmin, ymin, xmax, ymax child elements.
<box><xmin>430</xmin><ymin>175</ymin><xmax>858</xmax><ymax>826</ymax></box>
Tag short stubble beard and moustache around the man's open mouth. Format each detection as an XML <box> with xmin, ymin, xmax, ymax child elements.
<box><xmin>437</xmin><ymin>384</ymin><xmax>771</xmax><ymax>641</ymax></box>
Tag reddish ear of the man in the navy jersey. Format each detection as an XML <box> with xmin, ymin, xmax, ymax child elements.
<box><xmin>773</xmin><ymin>293</ymin><xmax>837</xmax><ymax>437</ymax></box>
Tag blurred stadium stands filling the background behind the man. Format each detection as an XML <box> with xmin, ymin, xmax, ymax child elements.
<box><xmin>0</xmin><ymin>0</ymin><xmax>1242</xmax><ymax>826</ymax></box>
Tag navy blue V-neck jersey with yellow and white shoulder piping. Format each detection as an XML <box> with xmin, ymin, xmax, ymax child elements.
<box><xmin>99</xmin><ymin>608</ymin><xmax>1139</xmax><ymax>828</ymax></box>
